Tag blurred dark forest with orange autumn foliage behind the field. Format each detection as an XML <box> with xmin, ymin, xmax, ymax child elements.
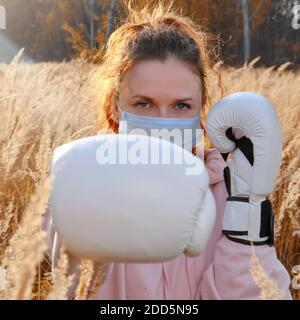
<box><xmin>1</xmin><ymin>0</ymin><xmax>300</xmax><ymax>66</ymax></box>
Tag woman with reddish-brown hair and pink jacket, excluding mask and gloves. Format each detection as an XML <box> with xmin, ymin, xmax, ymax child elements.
<box><xmin>44</xmin><ymin>1</ymin><xmax>290</xmax><ymax>299</ymax></box>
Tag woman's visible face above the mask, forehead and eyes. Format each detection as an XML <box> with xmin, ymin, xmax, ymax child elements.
<box><xmin>117</xmin><ymin>56</ymin><xmax>202</xmax><ymax>119</ymax></box>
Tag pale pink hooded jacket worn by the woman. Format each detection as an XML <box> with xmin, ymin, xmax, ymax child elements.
<box><xmin>42</xmin><ymin>149</ymin><xmax>291</xmax><ymax>300</ymax></box>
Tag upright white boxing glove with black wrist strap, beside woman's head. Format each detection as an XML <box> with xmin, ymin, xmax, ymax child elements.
<box><xmin>206</xmin><ymin>92</ymin><xmax>282</xmax><ymax>245</ymax></box>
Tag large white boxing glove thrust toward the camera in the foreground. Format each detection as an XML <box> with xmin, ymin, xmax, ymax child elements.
<box><xmin>50</xmin><ymin>134</ymin><xmax>216</xmax><ymax>263</ymax></box>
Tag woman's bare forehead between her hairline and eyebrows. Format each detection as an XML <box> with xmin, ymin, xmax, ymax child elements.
<box><xmin>124</xmin><ymin>57</ymin><xmax>201</xmax><ymax>98</ymax></box>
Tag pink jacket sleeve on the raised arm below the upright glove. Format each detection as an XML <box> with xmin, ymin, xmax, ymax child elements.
<box><xmin>198</xmin><ymin>182</ymin><xmax>291</xmax><ymax>300</ymax></box>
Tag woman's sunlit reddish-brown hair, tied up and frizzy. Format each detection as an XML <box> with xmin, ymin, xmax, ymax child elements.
<box><xmin>97</xmin><ymin>1</ymin><xmax>222</xmax><ymax>148</ymax></box>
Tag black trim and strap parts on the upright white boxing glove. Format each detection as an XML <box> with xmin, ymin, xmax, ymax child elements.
<box><xmin>222</xmin><ymin>127</ymin><xmax>275</xmax><ymax>246</ymax></box>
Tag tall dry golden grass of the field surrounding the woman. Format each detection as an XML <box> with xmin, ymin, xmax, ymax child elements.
<box><xmin>0</xmin><ymin>52</ymin><xmax>300</xmax><ymax>299</ymax></box>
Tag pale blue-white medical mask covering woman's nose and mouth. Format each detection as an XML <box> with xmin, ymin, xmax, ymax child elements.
<box><xmin>119</xmin><ymin>102</ymin><xmax>203</xmax><ymax>152</ymax></box>
